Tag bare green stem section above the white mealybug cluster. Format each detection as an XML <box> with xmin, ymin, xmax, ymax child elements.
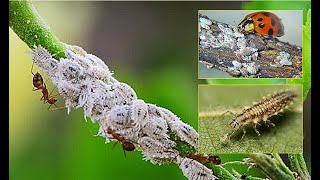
<box><xmin>9</xmin><ymin>0</ymin><xmax>65</xmax><ymax>59</ymax></box>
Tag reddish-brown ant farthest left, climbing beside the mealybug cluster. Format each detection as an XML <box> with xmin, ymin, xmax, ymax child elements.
<box><xmin>31</xmin><ymin>62</ymin><xmax>64</xmax><ymax>109</ymax></box>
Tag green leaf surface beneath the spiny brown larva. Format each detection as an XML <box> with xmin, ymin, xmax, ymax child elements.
<box><xmin>199</xmin><ymin>85</ymin><xmax>303</xmax><ymax>153</ymax></box>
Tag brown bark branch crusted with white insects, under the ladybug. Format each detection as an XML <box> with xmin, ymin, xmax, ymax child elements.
<box><xmin>199</xmin><ymin>14</ymin><xmax>302</xmax><ymax>78</ymax></box>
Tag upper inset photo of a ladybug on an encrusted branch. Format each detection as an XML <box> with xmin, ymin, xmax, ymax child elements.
<box><xmin>198</xmin><ymin>10</ymin><xmax>303</xmax><ymax>79</ymax></box>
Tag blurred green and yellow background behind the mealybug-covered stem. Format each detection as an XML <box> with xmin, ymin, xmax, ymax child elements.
<box><xmin>9</xmin><ymin>1</ymin><xmax>310</xmax><ymax>180</ymax></box>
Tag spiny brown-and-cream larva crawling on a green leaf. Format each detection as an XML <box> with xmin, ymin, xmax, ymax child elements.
<box><xmin>224</xmin><ymin>91</ymin><xmax>297</xmax><ymax>139</ymax></box>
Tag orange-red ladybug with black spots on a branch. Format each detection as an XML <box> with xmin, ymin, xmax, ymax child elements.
<box><xmin>238</xmin><ymin>11</ymin><xmax>284</xmax><ymax>37</ymax></box>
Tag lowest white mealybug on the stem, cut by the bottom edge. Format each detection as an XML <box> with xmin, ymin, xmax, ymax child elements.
<box><xmin>177</xmin><ymin>157</ymin><xmax>218</xmax><ymax>180</ymax></box>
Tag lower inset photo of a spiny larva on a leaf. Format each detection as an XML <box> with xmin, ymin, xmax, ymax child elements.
<box><xmin>198</xmin><ymin>85</ymin><xmax>303</xmax><ymax>154</ymax></box>
